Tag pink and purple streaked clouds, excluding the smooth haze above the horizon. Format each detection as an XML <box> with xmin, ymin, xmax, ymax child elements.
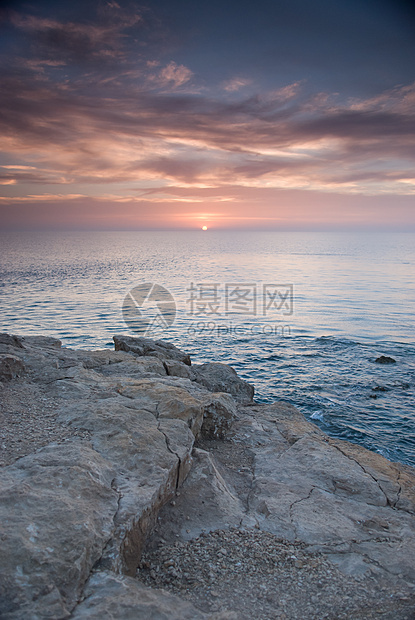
<box><xmin>0</xmin><ymin>2</ymin><xmax>415</xmax><ymax>206</ymax></box>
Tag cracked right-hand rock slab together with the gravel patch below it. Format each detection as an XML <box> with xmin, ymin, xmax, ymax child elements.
<box><xmin>137</xmin><ymin>403</ymin><xmax>415</xmax><ymax>620</ymax></box>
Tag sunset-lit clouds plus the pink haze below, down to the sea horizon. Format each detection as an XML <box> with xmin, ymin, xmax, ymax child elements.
<box><xmin>0</xmin><ymin>1</ymin><xmax>415</xmax><ymax>227</ymax></box>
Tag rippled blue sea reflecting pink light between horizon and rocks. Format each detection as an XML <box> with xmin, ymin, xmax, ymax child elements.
<box><xmin>0</xmin><ymin>230</ymin><xmax>415</xmax><ymax>466</ymax></box>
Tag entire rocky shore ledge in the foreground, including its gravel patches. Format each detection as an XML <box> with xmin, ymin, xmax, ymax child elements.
<box><xmin>0</xmin><ymin>334</ymin><xmax>415</xmax><ymax>620</ymax></box>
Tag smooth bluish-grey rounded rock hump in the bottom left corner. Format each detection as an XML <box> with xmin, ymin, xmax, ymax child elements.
<box><xmin>0</xmin><ymin>444</ymin><xmax>118</xmax><ymax>620</ymax></box>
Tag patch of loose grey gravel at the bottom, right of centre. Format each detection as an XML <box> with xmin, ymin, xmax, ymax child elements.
<box><xmin>137</xmin><ymin>528</ymin><xmax>415</xmax><ymax>620</ymax></box>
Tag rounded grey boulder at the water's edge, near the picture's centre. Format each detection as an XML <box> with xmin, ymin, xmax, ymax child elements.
<box><xmin>192</xmin><ymin>362</ymin><xmax>254</xmax><ymax>404</ymax></box>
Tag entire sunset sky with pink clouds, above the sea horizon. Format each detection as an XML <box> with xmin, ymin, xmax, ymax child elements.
<box><xmin>0</xmin><ymin>0</ymin><xmax>415</xmax><ymax>231</ymax></box>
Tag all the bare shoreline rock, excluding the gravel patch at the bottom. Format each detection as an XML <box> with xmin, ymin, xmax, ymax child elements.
<box><xmin>0</xmin><ymin>334</ymin><xmax>415</xmax><ymax>620</ymax></box>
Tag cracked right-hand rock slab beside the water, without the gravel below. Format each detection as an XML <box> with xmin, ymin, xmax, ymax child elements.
<box><xmin>149</xmin><ymin>403</ymin><xmax>415</xmax><ymax>604</ymax></box>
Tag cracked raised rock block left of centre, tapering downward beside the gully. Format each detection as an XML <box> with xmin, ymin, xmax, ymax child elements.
<box><xmin>58</xmin><ymin>397</ymin><xmax>194</xmax><ymax>574</ymax></box>
